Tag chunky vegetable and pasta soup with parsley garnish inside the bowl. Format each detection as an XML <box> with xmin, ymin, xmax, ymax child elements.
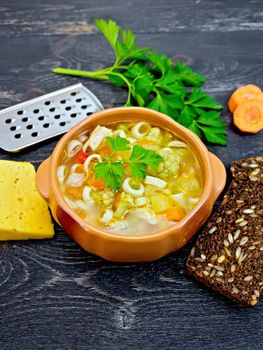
<box><xmin>57</xmin><ymin>122</ymin><xmax>203</xmax><ymax>236</ymax></box>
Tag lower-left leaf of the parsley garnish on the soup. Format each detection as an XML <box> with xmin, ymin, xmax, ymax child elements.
<box><xmin>94</xmin><ymin>162</ymin><xmax>124</xmax><ymax>191</ymax></box>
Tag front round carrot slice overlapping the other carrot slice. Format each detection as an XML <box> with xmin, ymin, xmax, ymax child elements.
<box><xmin>233</xmin><ymin>100</ymin><xmax>263</xmax><ymax>134</ymax></box>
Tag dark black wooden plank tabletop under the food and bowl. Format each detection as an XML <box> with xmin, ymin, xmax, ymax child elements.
<box><xmin>0</xmin><ymin>0</ymin><xmax>263</xmax><ymax>350</ymax></box>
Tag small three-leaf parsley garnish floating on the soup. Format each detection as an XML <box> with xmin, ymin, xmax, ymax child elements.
<box><xmin>94</xmin><ymin>136</ymin><xmax>163</xmax><ymax>191</ymax></box>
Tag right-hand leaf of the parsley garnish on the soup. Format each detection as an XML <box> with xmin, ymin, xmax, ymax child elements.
<box><xmin>129</xmin><ymin>145</ymin><xmax>163</xmax><ymax>179</ymax></box>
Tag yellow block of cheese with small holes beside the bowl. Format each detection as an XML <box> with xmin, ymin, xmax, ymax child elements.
<box><xmin>0</xmin><ymin>160</ymin><xmax>54</xmax><ymax>241</ymax></box>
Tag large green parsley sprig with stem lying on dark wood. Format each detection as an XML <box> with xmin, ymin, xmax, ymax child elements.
<box><xmin>53</xmin><ymin>19</ymin><xmax>226</xmax><ymax>145</ymax></box>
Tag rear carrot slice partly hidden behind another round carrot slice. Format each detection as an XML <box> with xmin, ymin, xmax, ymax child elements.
<box><xmin>228</xmin><ymin>84</ymin><xmax>263</xmax><ymax>113</ymax></box>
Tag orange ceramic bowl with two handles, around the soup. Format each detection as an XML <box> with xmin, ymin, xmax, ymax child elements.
<box><xmin>37</xmin><ymin>107</ymin><xmax>226</xmax><ymax>262</ymax></box>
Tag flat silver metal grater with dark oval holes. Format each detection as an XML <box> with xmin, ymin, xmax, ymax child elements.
<box><xmin>0</xmin><ymin>84</ymin><xmax>103</xmax><ymax>152</ymax></box>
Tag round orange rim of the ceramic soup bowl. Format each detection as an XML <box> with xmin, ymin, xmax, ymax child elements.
<box><xmin>49</xmin><ymin>107</ymin><xmax>213</xmax><ymax>242</ymax></box>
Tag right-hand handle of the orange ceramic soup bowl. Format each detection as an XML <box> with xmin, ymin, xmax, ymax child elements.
<box><xmin>209</xmin><ymin>152</ymin><xmax>226</xmax><ymax>202</ymax></box>
